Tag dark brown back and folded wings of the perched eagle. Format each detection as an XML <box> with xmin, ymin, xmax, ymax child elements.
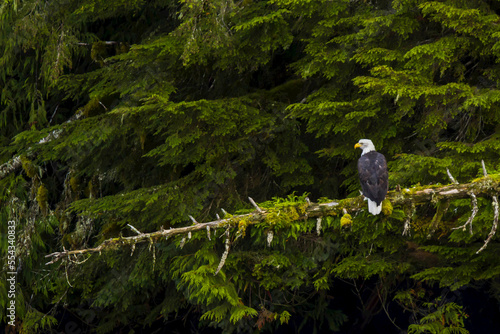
<box><xmin>358</xmin><ymin>151</ymin><xmax>389</xmax><ymax>205</ymax></box>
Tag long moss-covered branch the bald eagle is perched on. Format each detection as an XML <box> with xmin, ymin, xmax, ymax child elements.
<box><xmin>45</xmin><ymin>174</ymin><xmax>500</xmax><ymax>264</ymax></box>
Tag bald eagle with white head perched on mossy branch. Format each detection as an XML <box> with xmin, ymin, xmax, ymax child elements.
<box><xmin>354</xmin><ymin>139</ymin><xmax>389</xmax><ymax>215</ymax></box>
